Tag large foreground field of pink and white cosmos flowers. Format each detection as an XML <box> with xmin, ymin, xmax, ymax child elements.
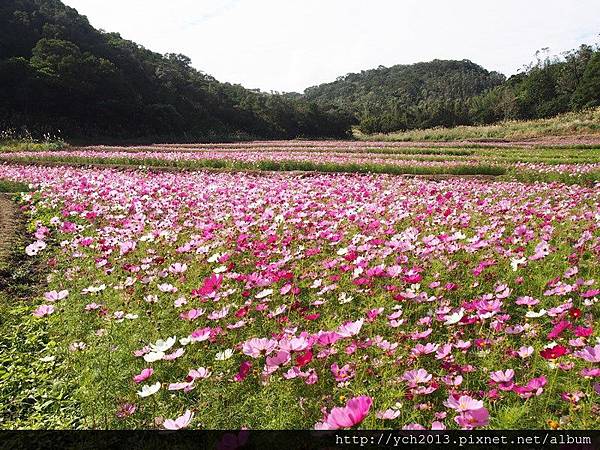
<box><xmin>0</xmin><ymin>142</ymin><xmax>600</xmax><ymax>429</ymax></box>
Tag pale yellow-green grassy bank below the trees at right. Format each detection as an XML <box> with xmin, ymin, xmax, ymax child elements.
<box><xmin>355</xmin><ymin>108</ymin><xmax>600</xmax><ymax>141</ymax></box>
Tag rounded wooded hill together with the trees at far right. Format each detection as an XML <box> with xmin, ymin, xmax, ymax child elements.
<box><xmin>305</xmin><ymin>45</ymin><xmax>600</xmax><ymax>133</ymax></box>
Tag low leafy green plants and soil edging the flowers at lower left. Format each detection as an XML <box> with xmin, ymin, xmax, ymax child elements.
<box><xmin>0</xmin><ymin>192</ymin><xmax>78</xmax><ymax>429</ymax></box>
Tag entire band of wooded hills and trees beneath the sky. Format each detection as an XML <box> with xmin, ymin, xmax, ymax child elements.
<box><xmin>0</xmin><ymin>0</ymin><xmax>600</xmax><ymax>141</ymax></box>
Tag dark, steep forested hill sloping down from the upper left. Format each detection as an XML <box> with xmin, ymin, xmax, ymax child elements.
<box><xmin>0</xmin><ymin>0</ymin><xmax>350</xmax><ymax>141</ymax></box>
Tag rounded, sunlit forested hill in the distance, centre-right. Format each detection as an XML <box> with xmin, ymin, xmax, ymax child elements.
<box><xmin>305</xmin><ymin>60</ymin><xmax>505</xmax><ymax>132</ymax></box>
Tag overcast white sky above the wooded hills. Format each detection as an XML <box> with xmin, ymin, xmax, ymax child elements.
<box><xmin>63</xmin><ymin>0</ymin><xmax>600</xmax><ymax>92</ymax></box>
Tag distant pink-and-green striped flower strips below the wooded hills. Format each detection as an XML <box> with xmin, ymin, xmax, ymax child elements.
<box><xmin>0</xmin><ymin>141</ymin><xmax>600</xmax><ymax>184</ymax></box>
